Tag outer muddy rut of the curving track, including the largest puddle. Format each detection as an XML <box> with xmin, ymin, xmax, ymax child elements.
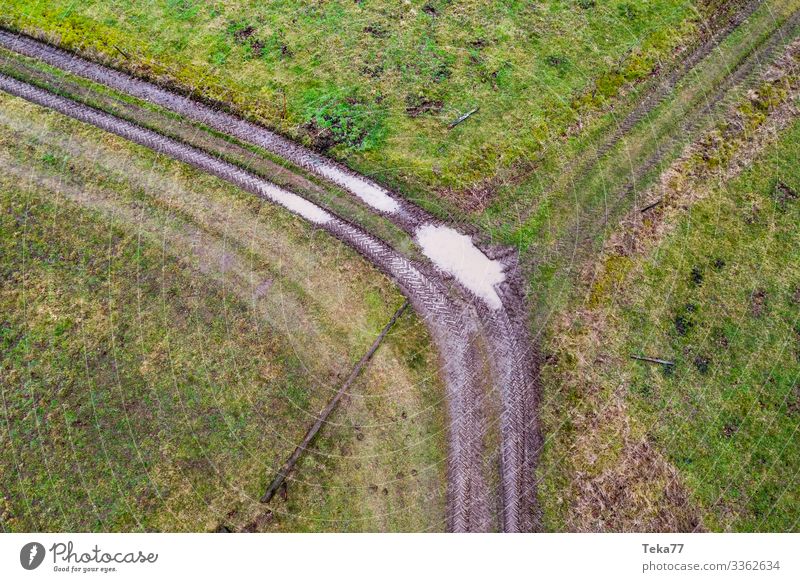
<box><xmin>0</xmin><ymin>30</ymin><xmax>538</xmax><ymax>531</ymax></box>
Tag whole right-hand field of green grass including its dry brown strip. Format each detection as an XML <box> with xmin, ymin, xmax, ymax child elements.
<box><xmin>541</xmin><ymin>64</ymin><xmax>800</xmax><ymax>531</ymax></box>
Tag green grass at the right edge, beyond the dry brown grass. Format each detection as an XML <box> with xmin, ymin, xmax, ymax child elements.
<box><xmin>624</xmin><ymin>141</ymin><xmax>800</xmax><ymax>531</ymax></box>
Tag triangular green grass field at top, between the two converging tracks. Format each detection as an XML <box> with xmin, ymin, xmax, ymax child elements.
<box><xmin>0</xmin><ymin>0</ymin><xmax>720</xmax><ymax>208</ymax></box>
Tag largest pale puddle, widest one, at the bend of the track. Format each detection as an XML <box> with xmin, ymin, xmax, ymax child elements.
<box><xmin>416</xmin><ymin>224</ymin><xmax>506</xmax><ymax>309</ymax></box>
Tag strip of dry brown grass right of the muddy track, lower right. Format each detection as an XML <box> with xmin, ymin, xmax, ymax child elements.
<box><xmin>545</xmin><ymin>309</ymin><xmax>702</xmax><ymax>531</ymax></box>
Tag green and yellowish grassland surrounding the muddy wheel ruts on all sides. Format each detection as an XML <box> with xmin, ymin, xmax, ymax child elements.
<box><xmin>0</xmin><ymin>0</ymin><xmax>800</xmax><ymax>531</ymax></box>
